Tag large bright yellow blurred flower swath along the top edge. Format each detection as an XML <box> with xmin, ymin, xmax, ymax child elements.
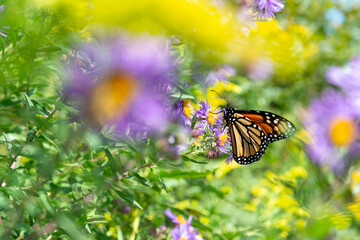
<box><xmin>47</xmin><ymin>0</ymin><xmax>246</xmax><ymax>62</ymax></box>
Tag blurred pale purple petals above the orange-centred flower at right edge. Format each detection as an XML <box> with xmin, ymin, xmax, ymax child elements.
<box><xmin>326</xmin><ymin>54</ymin><xmax>360</xmax><ymax>112</ymax></box>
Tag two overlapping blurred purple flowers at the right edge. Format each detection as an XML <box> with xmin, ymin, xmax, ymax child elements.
<box><xmin>305</xmin><ymin>56</ymin><xmax>360</xmax><ymax>174</ymax></box>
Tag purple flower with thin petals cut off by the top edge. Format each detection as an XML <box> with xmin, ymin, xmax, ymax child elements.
<box><xmin>255</xmin><ymin>0</ymin><xmax>284</xmax><ymax>19</ymax></box>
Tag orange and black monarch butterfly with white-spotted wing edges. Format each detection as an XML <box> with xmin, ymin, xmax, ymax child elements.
<box><xmin>223</xmin><ymin>105</ymin><xmax>295</xmax><ymax>165</ymax></box>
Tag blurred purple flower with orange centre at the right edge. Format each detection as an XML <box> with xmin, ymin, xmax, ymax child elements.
<box><xmin>305</xmin><ymin>90</ymin><xmax>360</xmax><ymax>174</ymax></box>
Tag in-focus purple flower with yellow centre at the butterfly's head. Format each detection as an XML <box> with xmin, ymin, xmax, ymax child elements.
<box><xmin>196</xmin><ymin>100</ymin><xmax>219</xmax><ymax>132</ymax></box>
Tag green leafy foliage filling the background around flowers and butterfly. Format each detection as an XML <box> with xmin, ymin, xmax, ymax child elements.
<box><xmin>0</xmin><ymin>0</ymin><xmax>360</xmax><ymax>240</ymax></box>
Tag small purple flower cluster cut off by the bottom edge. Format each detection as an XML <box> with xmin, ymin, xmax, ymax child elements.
<box><xmin>165</xmin><ymin>209</ymin><xmax>202</xmax><ymax>240</ymax></box>
